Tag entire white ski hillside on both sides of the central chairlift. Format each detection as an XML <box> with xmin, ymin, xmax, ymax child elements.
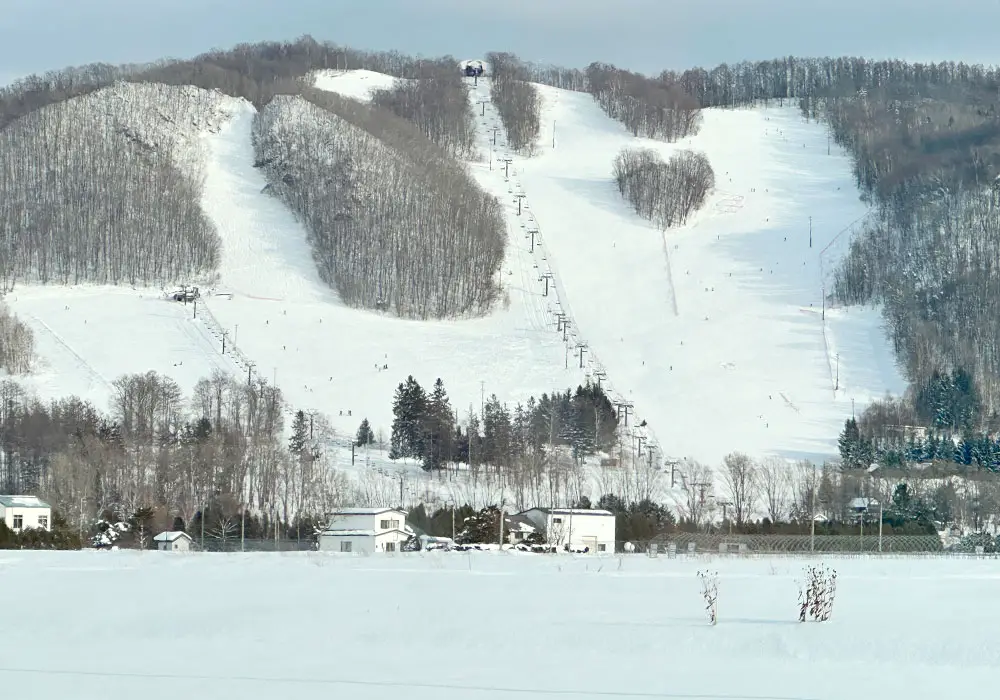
<box><xmin>8</xmin><ymin>71</ymin><xmax>904</xmax><ymax>470</ymax></box>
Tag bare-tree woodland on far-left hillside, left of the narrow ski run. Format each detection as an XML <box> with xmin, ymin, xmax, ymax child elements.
<box><xmin>0</xmin><ymin>84</ymin><xmax>221</xmax><ymax>290</ymax></box>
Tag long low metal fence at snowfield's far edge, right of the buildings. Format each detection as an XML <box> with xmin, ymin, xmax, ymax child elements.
<box><xmin>632</xmin><ymin>532</ymin><xmax>952</xmax><ymax>556</ymax></box>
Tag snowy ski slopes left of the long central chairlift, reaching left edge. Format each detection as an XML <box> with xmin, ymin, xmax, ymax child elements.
<box><xmin>8</xmin><ymin>82</ymin><xmax>584</xmax><ymax>456</ymax></box>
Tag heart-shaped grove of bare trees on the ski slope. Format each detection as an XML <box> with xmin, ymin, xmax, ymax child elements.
<box><xmin>613</xmin><ymin>148</ymin><xmax>715</xmax><ymax>229</ymax></box>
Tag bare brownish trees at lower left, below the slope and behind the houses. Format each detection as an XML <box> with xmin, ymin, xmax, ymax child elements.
<box><xmin>0</xmin><ymin>372</ymin><xmax>348</xmax><ymax>536</ymax></box>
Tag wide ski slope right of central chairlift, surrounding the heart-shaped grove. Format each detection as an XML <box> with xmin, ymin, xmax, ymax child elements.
<box><xmin>468</xmin><ymin>81</ymin><xmax>905</xmax><ymax>463</ymax></box>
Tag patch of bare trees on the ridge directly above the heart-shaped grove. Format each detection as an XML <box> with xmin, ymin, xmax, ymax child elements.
<box><xmin>586</xmin><ymin>63</ymin><xmax>701</xmax><ymax>143</ymax></box>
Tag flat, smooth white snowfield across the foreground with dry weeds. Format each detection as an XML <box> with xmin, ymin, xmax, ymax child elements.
<box><xmin>0</xmin><ymin>552</ymin><xmax>1000</xmax><ymax>700</ymax></box>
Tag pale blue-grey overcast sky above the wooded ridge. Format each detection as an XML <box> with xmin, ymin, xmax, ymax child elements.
<box><xmin>0</xmin><ymin>0</ymin><xmax>1000</xmax><ymax>82</ymax></box>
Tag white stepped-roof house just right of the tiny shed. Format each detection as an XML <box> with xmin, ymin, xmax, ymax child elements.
<box><xmin>319</xmin><ymin>508</ymin><xmax>413</xmax><ymax>554</ymax></box>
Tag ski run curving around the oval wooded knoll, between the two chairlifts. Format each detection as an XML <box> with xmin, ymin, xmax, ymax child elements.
<box><xmin>172</xmin><ymin>93</ymin><xmax>583</xmax><ymax>437</ymax></box>
